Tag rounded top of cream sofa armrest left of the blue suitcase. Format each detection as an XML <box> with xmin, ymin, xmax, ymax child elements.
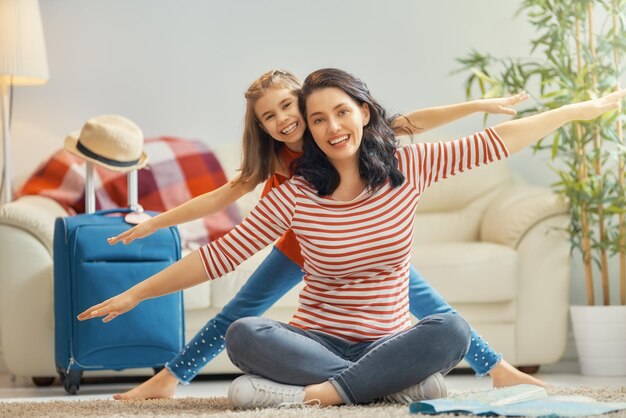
<box><xmin>0</xmin><ymin>196</ymin><xmax>68</xmax><ymax>254</ymax></box>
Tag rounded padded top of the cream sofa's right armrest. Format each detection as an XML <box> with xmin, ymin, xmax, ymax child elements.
<box><xmin>480</xmin><ymin>184</ymin><xmax>567</xmax><ymax>248</ymax></box>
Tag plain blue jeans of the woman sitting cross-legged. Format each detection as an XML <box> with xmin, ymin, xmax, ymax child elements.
<box><xmin>226</xmin><ymin>313</ymin><xmax>470</xmax><ymax>404</ymax></box>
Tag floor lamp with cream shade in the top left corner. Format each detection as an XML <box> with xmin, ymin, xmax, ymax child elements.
<box><xmin>0</xmin><ymin>0</ymin><xmax>48</xmax><ymax>204</ymax></box>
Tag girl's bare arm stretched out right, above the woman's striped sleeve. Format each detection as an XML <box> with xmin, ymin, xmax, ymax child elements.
<box><xmin>392</xmin><ymin>91</ymin><xmax>528</xmax><ymax>136</ymax></box>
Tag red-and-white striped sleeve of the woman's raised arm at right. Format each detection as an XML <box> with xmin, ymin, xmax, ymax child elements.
<box><xmin>398</xmin><ymin>128</ymin><xmax>509</xmax><ymax>193</ymax></box>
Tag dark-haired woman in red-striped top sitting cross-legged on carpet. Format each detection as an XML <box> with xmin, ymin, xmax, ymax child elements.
<box><xmin>221</xmin><ymin>69</ymin><xmax>626</xmax><ymax>408</ymax></box>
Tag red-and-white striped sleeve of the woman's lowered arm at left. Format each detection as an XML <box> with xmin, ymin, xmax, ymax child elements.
<box><xmin>198</xmin><ymin>182</ymin><xmax>296</xmax><ymax>280</ymax></box>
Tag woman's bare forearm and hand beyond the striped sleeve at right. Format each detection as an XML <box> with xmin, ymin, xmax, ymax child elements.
<box><xmin>494</xmin><ymin>89</ymin><xmax>626</xmax><ymax>153</ymax></box>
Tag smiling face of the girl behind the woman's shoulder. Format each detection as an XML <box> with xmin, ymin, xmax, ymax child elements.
<box><xmin>254</xmin><ymin>88</ymin><xmax>306</xmax><ymax>144</ymax></box>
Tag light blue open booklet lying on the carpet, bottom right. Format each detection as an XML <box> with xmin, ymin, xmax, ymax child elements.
<box><xmin>409</xmin><ymin>385</ymin><xmax>626</xmax><ymax>417</ymax></box>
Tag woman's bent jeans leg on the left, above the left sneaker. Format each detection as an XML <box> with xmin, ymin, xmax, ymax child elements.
<box><xmin>226</xmin><ymin>317</ymin><xmax>353</xmax><ymax>386</ymax></box>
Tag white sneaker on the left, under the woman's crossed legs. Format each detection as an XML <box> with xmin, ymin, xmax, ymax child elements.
<box><xmin>228</xmin><ymin>374</ymin><xmax>304</xmax><ymax>409</ymax></box>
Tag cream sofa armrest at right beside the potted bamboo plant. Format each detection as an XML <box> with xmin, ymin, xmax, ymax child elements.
<box><xmin>480</xmin><ymin>184</ymin><xmax>571</xmax><ymax>366</ymax></box>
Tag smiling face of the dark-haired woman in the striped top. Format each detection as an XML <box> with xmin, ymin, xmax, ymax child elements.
<box><xmin>306</xmin><ymin>87</ymin><xmax>370</xmax><ymax>167</ymax></box>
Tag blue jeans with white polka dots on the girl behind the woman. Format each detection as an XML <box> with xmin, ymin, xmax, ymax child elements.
<box><xmin>165</xmin><ymin>247</ymin><xmax>502</xmax><ymax>383</ymax></box>
